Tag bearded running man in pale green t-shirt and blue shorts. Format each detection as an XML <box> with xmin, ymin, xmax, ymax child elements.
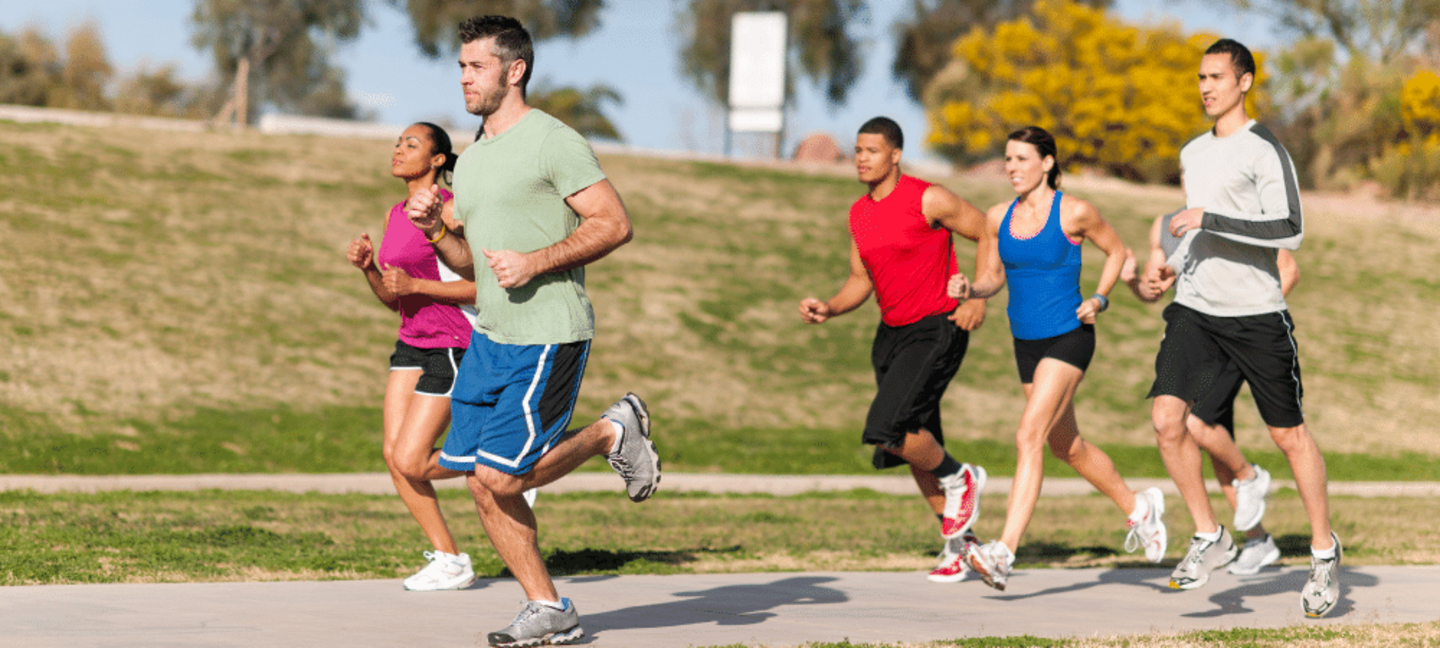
<box><xmin>408</xmin><ymin>16</ymin><xmax>660</xmax><ymax>647</ymax></box>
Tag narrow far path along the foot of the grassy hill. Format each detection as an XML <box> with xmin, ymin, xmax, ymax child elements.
<box><xmin>11</xmin><ymin>471</ymin><xmax>1440</xmax><ymax>497</ymax></box>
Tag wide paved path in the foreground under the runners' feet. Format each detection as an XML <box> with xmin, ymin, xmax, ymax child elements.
<box><xmin>0</xmin><ymin>567</ymin><xmax>1440</xmax><ymax>648</ymax></box>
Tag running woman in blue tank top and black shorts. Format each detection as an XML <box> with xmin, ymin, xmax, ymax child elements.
<box><xmin>949</xmin><ymin>127</ymin><xmax>1166</xmax><ymax>589</ymax></box>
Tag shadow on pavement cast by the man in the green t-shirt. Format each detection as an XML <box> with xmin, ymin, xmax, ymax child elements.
<box><xmin>580</xmin><ymin>576</ymin><xmax>850</xmax><ymax>636</ymax></box>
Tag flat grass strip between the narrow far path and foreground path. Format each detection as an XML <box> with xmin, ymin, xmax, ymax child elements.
<box><xmin>0</xmin><ymin>488</ymin><xmax>1437</xmax><ymax>585</ymax></box>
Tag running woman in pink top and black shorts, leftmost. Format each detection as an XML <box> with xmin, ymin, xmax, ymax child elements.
<box><xmin>346</xmin><ymin>122</ymin><xmax>475</xmax><ymax>590</ymax></box>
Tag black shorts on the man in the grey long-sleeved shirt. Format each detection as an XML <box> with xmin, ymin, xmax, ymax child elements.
<box><xmin>1149</xmin><ymin>302</ymin><xmax>1305</xmax><ymax>428</ymax></box>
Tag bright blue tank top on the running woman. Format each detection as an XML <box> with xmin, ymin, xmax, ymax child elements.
<box><xmin>999</xmin><ymin>192</ymin><xmax>1081</xmax><ymax>340</ymax></box>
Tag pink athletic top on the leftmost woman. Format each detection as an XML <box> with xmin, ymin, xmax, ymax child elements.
<box><xmin>376</xmin><ymin>189</ymin><xmax>471</xmax><ymax>348</ymax></box>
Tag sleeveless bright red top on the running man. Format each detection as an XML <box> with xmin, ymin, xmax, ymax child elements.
<box><xmin>850</xmin><ymin>176</ymin><xmax>959</xmax><ymax>327</ymax></box>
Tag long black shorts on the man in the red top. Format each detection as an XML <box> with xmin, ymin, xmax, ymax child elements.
<box><xmin>861</xmin><ymin>312</ymin><xmax>971</xmax><ymax>468</ymax></box>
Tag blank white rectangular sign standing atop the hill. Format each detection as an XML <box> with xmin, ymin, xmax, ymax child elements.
<box><xmin>726</xmin><ymin>12</ymin><xmax>785</xmax><ymax>154</ymax></box>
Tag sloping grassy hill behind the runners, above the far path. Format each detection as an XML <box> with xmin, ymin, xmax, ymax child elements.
<box><xmin>0</xmin><ymin>122</ymin><xmax>1440</xmax><ymax>480</ymax></box>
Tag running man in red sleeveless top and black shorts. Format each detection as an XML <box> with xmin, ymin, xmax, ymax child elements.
<box><xmin>799</xmin><ymin>117</ymin><xmax>985</xmax><ymax>582</ymax></box>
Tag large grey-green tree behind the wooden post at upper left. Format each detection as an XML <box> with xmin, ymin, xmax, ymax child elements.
<box><xmin>190</xmin><ymin>0</ymin><xmax>364</xmax><ymax>120</ymax></box>
